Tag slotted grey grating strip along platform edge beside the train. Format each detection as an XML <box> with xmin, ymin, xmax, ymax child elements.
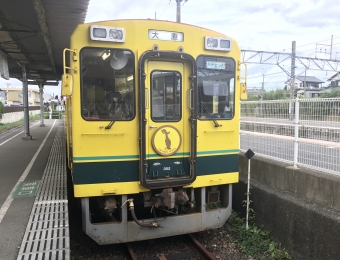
<box><xmin>17</xmin><ymin>124</ymin><xmax>70</xmax><ymax>260</ymax></box>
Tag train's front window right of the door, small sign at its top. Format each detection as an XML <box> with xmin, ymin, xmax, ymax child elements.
<box><xmin>196</xmin><ymin>56</ymin><xmax>235</xmax><ymax>120</ymax></box>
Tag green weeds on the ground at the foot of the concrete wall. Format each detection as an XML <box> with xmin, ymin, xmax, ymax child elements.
<box><xmin>228</xmin><ymin>212</ymin><xmax>292</xmax><ymax>260</ymax></box>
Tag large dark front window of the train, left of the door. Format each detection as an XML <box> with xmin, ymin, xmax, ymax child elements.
<box><xmin>80</xmin><ymin>48</ymin><xmax>135</xmax><ymax>121</ymax></box>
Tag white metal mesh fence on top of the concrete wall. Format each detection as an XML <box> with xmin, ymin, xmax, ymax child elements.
<box><xmin>240</xmin><ymin>98</ymin><xmax>340</xmax><ymax>175</ymax></box>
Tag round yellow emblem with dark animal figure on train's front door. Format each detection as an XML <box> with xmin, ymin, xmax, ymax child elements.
<box><xmin>151</xmin><ymin>125</ymin><xmax>182</xmax><ymax>156</ymax></box>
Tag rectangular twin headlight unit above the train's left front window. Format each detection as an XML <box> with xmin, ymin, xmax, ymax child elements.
<box><xmin>90</xmin><ymin>25</ymin><xmax>125</xmax><ymax>42</ymax></box>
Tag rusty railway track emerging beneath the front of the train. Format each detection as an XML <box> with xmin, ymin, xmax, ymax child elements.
<box><xmin>126</xmin><ymin>234</ymin><xmax>216</xmax><ymax>260</ymax></box>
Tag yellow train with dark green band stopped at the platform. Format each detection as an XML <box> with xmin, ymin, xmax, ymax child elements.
<box><xmin>62</xmin><ymin>20</ymin><xmax>246</xmax><ymax>244</ymax></box>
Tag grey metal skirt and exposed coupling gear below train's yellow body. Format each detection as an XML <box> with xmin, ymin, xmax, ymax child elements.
<box><xmin>81</xmin><ymin>184</ymin><xmax>232</xmax><ymax>245</ymax></box>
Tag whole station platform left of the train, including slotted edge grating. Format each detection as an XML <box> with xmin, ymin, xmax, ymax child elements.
<box><xmin>0</xmin><ymin>119</ymin><xmax>70</xmax><ymax>260</ymax></box>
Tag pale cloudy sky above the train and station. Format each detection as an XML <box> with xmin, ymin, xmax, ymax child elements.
<box><xmin>0</xmin><ymin>0</ymin><xmax>340</xmax><ymax>93</ymax></box>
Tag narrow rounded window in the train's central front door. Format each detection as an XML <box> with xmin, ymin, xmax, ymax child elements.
<box><xmin>150</xmin><ymin>71</ymin><xmax>182</xmax><ymax>122</ymax></box>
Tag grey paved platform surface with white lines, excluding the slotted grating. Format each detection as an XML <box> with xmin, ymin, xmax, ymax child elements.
<box><xmin>0</xmin><ymin>120</ymin><xmax>61</xmax><ymax>260</ymax></box>
